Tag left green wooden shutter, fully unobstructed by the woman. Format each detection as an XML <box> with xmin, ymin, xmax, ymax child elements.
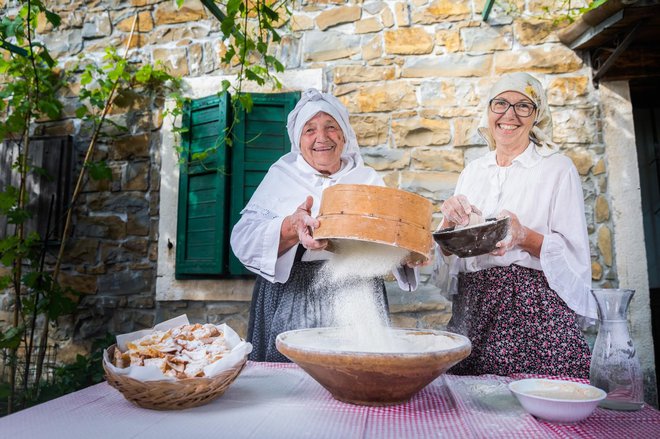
<box><xmin>175</xmin><ymin>93</ymin><xmax>229</xmax><ymax>278</ymax></box>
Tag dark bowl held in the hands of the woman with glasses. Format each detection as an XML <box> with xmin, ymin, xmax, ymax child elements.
<box><xmin>433</xmin><ymin>217</ymin><xmax>511</xmax><ymax>258</ymax></box>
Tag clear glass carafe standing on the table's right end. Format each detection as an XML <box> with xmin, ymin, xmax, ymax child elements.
<box><xmin>589</xmin><ymin>289</ymin><xmax>644</xmax><ymax>410</ymax></box>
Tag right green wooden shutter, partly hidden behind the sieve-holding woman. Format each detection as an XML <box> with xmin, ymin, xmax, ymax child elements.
<box><xmin>229</xmin><ymin>92</ymin><xmax>300</xmax><ymax>274</ymax></box>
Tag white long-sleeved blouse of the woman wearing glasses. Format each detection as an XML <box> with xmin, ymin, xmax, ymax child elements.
<box><xmin>434</xmin><ymin>143</ymin><xmax>597</xmax><ymax>319</ymax></box>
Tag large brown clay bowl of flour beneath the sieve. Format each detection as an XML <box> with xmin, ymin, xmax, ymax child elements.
<box><xmin>276</xmin><ymin>328</ymin><xmax>472</xmax><ymax>405</ymax></box>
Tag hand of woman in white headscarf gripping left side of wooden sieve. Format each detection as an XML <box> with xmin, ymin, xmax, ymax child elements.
<box><xmin>279</xmin><ymin>196</ymin><xmax>328</xmax><ymax>254</ymax></box>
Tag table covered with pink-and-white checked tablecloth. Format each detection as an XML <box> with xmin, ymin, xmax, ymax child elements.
<box><xmin>0</xmin><ymin>362</ymin><xmax>660</xmax><ymax>439</ymax></box>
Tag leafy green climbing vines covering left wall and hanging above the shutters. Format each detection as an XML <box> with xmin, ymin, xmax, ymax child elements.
<box><xmin>0</xmin><ymin>0</ymin><xmax>290</xmax><ymax>414</ymax></box>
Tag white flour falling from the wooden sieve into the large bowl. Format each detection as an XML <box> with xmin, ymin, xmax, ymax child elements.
<box><xmin>316</xmin><ymin>240</ymin><xmax>408</xmax><ymax>352</ymax></box>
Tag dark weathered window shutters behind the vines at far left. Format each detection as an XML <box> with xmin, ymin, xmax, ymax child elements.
<box><xmin>0</xmin><ymin>136</ymin><xmax>73</xmax><ymax>245</ymax></box>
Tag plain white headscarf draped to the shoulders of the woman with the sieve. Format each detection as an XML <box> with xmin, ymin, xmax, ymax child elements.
<box><xmin>243</xmin><ymin>89</ymin><xmax>384</xmax><ymax>216</ymax></box>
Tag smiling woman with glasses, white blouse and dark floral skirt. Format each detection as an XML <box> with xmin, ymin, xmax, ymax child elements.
<box><xmin>436</xmin><ymin>73</ymin><xmax>596</xmax><ymax>378</ymax></box>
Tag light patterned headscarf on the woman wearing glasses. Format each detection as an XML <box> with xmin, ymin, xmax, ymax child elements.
<box><xmin>477</xmin><ymin>72</ymin><xmax>559</xmax><ymax>156</ymax></box>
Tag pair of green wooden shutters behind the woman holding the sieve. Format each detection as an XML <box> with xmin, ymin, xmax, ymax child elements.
<box><xmin>175</xmin><ymin>92</ymin><xmax>300</xmax><ymax>279</ymax></box>
